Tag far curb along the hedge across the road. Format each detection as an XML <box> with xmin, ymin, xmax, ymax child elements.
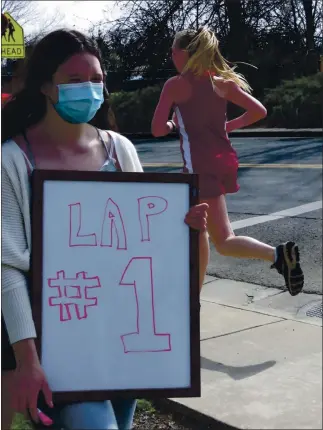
<box><xmin>122</xmin><ymin>128</ymin><xmax>323</xmax><ymax>140</ymax></box>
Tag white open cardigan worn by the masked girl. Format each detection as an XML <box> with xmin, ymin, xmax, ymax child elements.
<box><xmin>1</xmin><ymin>131</ymin><xmax>143</xmax><ymax>343</ymax></box>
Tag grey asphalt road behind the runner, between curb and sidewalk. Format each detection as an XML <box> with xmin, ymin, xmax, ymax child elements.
<box><xmin>134</xmin><ymin>138</ymin><xmax>323</xmax><ymax>294</ymax></box>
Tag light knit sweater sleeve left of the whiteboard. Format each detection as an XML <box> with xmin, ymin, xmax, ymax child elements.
<box><xmin>1</xmin><ymin>157</ymin><xmax>36</xmax><ymax>343</ymax></box>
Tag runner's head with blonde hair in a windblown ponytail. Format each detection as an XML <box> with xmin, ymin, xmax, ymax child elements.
<box><xmin>175</xmin><ymin>27</ymin><xmax>252</xmax><ymax>93</ymax></box>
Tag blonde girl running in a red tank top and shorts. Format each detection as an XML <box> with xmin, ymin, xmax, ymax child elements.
<box><xmin>152</xmin><ymin>27</ymin><xmax>304</xmax><ymax>296</ymax></box>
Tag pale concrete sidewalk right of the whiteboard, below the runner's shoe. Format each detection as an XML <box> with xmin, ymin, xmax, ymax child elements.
<box><xmin>172</xmin><ymin>277</ymin><xmax>322</xmax><ymax>429</ymax></box>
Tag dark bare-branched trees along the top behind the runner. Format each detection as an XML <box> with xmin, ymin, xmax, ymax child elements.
<box><xmin>93</xmin><ymin>0</ymin><xmax>323</xmax><ymax>95</ymax></box>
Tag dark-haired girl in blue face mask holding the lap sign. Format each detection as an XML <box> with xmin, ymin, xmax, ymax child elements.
<box><xmin>1</xmin><ymin>30</ymin><xmax>207</xmax><ymax>430</ymax></box>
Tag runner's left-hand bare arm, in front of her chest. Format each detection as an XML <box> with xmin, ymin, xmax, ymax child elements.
<box><xmin>151</xmin><ymin>79</ymin><xmax>174</xmax><ymax>137</ymax></box>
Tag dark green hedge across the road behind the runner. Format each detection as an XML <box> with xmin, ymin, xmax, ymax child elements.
<box><xmin>110</xmin><ymin>73</ymin><xmax>323</xmax><ymax>133</ymax></box>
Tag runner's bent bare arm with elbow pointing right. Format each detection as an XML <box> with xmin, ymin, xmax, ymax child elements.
<box><xmin>223</xmin><ymin>81</ymin><xmax>267</xmax><ymax>133</ymax></box>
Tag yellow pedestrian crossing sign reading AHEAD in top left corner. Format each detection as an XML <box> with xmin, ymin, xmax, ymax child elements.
<box><xmin>1</xmin><ymin>12</ymin><xmax>25</xmax><ymax>58</ymax></box>
